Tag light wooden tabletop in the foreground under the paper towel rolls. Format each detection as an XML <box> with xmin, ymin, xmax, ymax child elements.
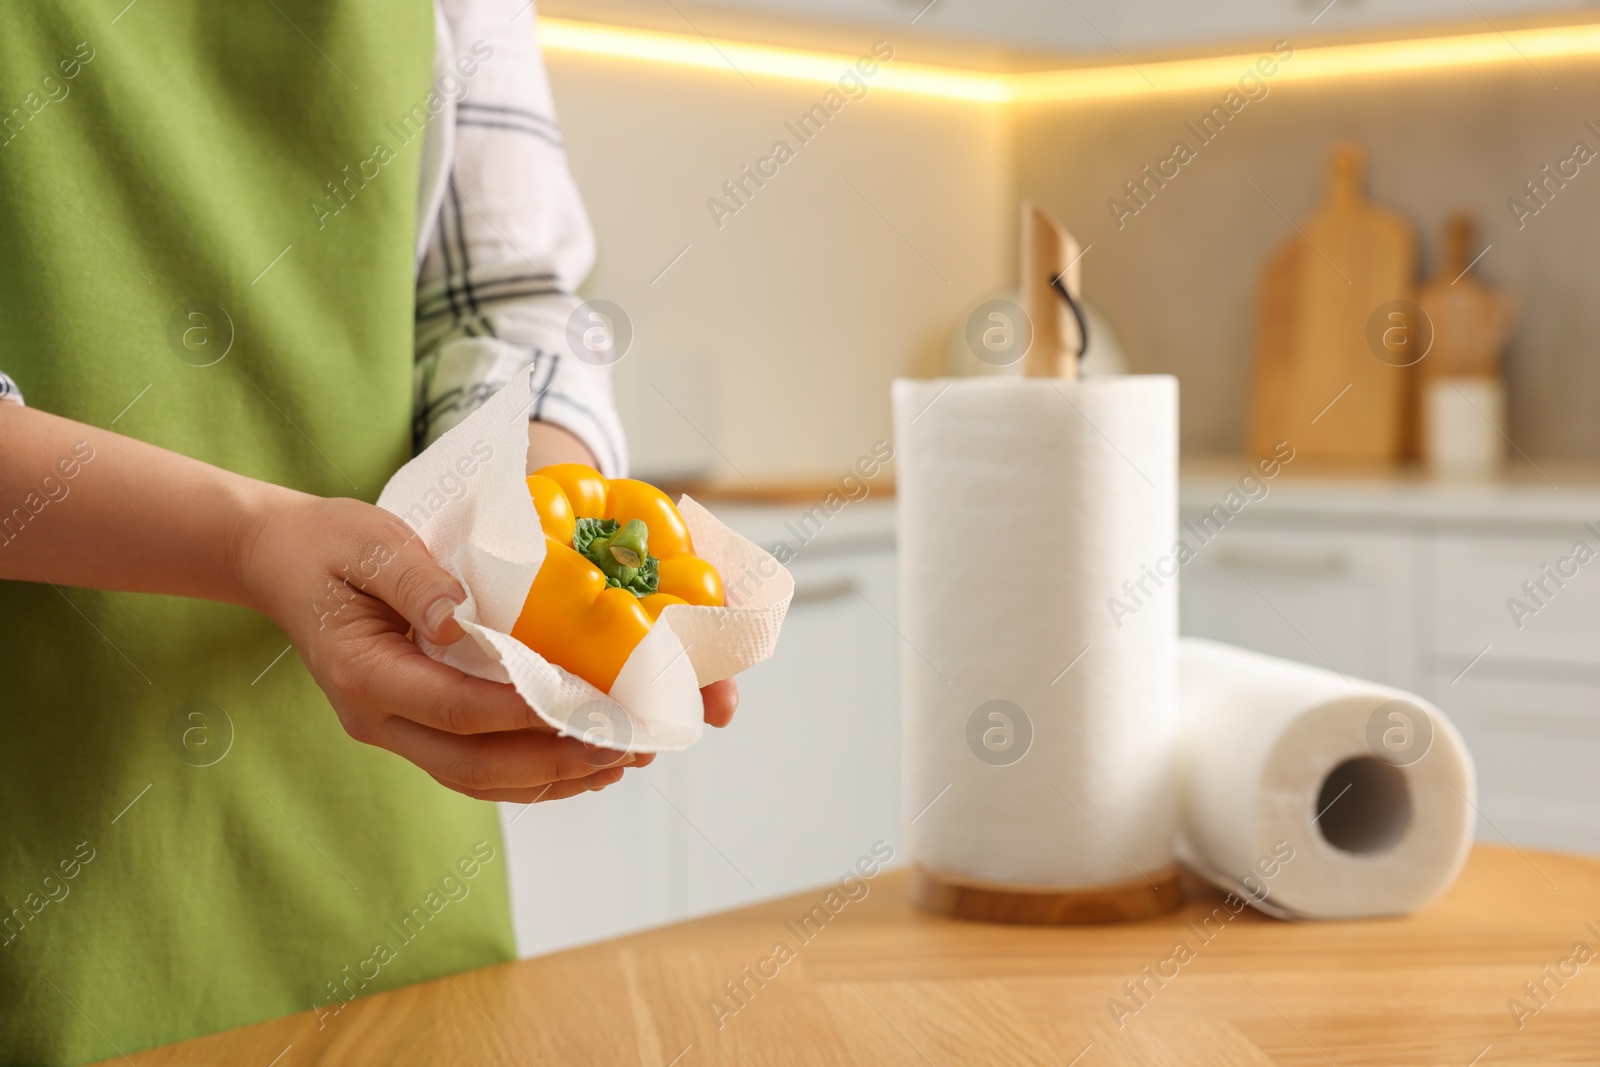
<box><xmin>107</xmin><ymin>846</ymin><xmax>1600</xmax><ymax>1067</ymax></box>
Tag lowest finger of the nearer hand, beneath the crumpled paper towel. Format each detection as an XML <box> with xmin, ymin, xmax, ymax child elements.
<box><xmin>371</xmin><ymin>717</ymin><xmax>632</xmax><ymax>793</ymax></box>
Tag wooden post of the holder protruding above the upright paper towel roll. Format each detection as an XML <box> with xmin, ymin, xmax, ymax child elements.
<box><xmin>1021</xmin><ymin>200</ymin><xmax>1085</xmax><ymax>378</ymax></box>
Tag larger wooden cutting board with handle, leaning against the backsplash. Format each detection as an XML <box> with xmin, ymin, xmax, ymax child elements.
<box><xmin>1248</xmin><ymin>144</ymin><xmax>1419</xmax><ymax>461</ymax></box>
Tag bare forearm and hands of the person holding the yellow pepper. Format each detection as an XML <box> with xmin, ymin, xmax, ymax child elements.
<box><xmin>0</xmin><ymin>405</ymin><xmax>738</xmax><ymax>801</ymax></box>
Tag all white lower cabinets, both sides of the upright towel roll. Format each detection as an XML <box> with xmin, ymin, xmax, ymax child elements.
<box><xmin>504</xmin><ymin>462</ymin><xmax>1600</xmax><ymax>955</ymax></box>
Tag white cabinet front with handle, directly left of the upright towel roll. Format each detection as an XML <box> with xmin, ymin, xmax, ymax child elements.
<box><xmin>650</xmin><ymin>549</ymin><xmax>901</xmax><ymax>913</ymax></box>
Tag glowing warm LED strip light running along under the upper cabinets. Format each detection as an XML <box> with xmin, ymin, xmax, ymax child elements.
<box><xmin>539</xmin><ymin>18</ymin><xmax>1600</xmax><ymax>104</ymax></box>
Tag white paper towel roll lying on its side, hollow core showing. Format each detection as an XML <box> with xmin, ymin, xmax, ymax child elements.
<box><xmin>1178</xmin><ymin>638</ymin><xmax>1477</xmax><ymax>918</ymax></box>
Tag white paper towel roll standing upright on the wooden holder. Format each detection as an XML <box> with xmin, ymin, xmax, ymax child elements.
<box><xmin>894</xmin><ymin>376</ymin><xmax>1178</xmax><ymax>888</ymax></box>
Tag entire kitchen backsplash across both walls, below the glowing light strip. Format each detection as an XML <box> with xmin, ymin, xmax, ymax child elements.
<box><xmin>550</xmin><ymin>40</ymin><xmax>1600</xmax><ymax>485</ymax></box>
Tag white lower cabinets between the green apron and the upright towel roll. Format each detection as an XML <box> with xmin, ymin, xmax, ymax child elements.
<box><xmin>502</xmin><ymin>499</ymin><xmax>901</xmax><ymax>955</ymax></box>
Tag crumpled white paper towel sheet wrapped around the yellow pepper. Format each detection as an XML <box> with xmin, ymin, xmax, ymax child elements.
<box><xmin>378</xmin><ymin>371</ymin><xmax>794</xmax><ymax>752</ymax></box>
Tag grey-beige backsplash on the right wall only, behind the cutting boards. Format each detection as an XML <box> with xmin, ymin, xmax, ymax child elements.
<box><xmin>1016</xmin><ymin>58</ymin><xmax>1600</xmax><ymax>459</ymax></box>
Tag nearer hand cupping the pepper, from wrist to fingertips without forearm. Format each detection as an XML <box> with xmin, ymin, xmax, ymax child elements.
<box><xmin>235</xmin><ymin>491</ymin><xmax>636</xmax><ymax>803</ymax></box>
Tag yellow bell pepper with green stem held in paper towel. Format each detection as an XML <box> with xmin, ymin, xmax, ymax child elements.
<box><xmin>510</xmin><ymin>464</ymin><xmax>723</xmax><ymax>693</ymax></box>
